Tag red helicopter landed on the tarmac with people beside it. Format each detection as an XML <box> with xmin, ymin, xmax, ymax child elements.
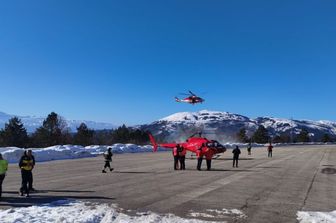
<box><xmin>149</xmin><ymin>133</ymin><xmax>226</xmax><ymax>170</ymax></box>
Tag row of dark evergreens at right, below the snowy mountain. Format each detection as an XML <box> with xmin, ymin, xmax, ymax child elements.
<box><xmin>237</xmin><ymin>125</ymin><xmax>336</xmax><ymax>144</ymax></box>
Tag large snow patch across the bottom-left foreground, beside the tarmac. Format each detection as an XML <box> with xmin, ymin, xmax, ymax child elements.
<box><xmin>0</xmin><ymin>200</ymin><xmax>218</xmax><ymax>223</ymax></box>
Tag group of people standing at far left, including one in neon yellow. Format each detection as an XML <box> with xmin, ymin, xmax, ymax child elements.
<box><xmin>0</xmin><ymin>149</ymin><xmax>35</xmax><ymax>198</ymax></box>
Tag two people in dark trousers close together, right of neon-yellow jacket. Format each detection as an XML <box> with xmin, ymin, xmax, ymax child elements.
<box><xmin>19</xmin><ymin>150</ymin><xmax>35</xmax><ymax>197</ymax></box>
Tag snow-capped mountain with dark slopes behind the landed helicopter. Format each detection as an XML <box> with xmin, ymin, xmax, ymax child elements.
<box><xmin>141</xmin><ymin>110</ymin><xmax>336</xmax><ymax>142</ymax></box>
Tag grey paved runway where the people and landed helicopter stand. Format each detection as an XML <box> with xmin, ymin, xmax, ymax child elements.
<box><xmin>0</xmin><ymin>145</ymin><xmax>336</xmax><ymax>223</ymax></box>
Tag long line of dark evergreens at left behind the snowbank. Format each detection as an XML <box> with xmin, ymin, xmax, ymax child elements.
<box><xmin>0</xmin><ymin>112</ymin><xmax>149</xmax><ymax>148</ymax></box>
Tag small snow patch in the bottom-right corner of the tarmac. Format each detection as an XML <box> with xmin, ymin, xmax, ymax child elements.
<box><xmin>297</xmin><ymin>211</ymin><xmax>336</xmax><ymax>223</ymax></box>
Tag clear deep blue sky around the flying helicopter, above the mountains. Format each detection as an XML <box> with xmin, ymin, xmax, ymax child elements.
<box><xmin>0</xmin><ymin>0</ymin><xmax>336</xmax><ymax>125</ymax></box>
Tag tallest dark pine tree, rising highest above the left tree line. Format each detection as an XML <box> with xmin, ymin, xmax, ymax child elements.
<box><xmin>33</xmin><ymin>112</ymin><xmax>69</xmax><ymax>147</ymax></box>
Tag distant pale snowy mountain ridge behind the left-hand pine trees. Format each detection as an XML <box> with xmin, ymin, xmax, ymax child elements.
<box><xmin>0</xmin><ymin>112</ymin><xmax>116</xmax><ymax>132</ymax></box>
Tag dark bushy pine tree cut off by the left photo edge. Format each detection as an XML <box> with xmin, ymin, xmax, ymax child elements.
<box><xmin>0</xmin><ymin>117</ymin><xmax>29</xmax><ymax>147</ymax></box>
